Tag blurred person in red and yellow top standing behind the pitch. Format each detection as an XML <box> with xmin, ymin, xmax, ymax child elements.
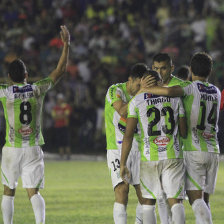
<box><xmin>52</xmin><ymin>93</ymin><xmax>72</xmax><ymax>159</ymax></box>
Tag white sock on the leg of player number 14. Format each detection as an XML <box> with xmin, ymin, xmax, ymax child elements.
<box><xmin>192</xmin><ymin>199</ymin><xmax>212</xmax><ymax>224</ymax></box>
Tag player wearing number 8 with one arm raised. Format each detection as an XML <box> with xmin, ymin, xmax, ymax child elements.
<box><xmin>0</xmin><ymin>26</ymin><xmax>70</xmax><ymax>224</ymax></box>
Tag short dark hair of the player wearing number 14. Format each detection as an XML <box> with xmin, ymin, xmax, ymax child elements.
<box><xmin>191</xmin><ymin>52</ymin><xmax>213</xmax><ymax>78</ymax></box>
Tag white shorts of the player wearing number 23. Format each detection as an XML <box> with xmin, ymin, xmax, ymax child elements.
<box><xmin>140</xmin><ymin>159</ymin><xmax>185</xmax><ymax>199</ymax></box>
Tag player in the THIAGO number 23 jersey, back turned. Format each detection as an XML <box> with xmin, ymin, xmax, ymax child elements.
<box><xmin>120</xmin><ymin>71</ymin><xmax>186</xmax><ymax>224</ymax></box>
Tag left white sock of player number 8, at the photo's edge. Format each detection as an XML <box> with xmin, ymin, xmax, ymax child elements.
<box><xmin>1</xmin><ymin>195</ymin><xmax>14</xmax><ymax>224</ymax></box>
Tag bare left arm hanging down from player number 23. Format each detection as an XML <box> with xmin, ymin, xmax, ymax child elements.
<box><xmin>120</xmin><ymin>118</ymin><xmax>138</xmax><ymax>183</ymax></box>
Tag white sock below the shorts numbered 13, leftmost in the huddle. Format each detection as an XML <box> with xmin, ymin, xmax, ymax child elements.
<box><xmin>113</xmin><ymin>202</ymin><xmax>127</xmax><ymax>224</ymax></box>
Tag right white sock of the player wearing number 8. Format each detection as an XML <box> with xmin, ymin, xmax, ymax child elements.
<box><xmin>30</xmin><ymin>194</ymin><xmax>45</xmax><ymax>224</ymax></box>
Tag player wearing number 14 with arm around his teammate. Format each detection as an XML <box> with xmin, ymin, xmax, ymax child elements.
<box><xmin>141</xmin><ymin>52</ymin><xmax>221</xmax><ymax>224</ymax></box>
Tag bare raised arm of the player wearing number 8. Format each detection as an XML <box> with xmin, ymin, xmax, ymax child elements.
<box><xmin>49</xmin><ymin>25</ymin><xmax>70</xmax><ymax>83</ymax></box>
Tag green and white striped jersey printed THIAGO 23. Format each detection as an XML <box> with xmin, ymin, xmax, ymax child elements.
<box><xmin>128</xmin><ymin>93</ymin><xmax>185</xmax><ymax>161</ymax></box>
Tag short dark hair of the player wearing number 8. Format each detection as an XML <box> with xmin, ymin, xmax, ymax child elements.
<box><xmin>8</xmin><ymin>59</ymin><xmax>26</xmax><ymax>82</ymax></box>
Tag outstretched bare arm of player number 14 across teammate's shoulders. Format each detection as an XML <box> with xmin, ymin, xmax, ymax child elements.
<box><xmin>141</xmin><ymin>86</ymin><xmax>184</xmax><ymax>97</ymax></box>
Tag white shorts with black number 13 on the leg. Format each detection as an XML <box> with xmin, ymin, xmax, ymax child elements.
<box><xmin>107</xmin><ymin>149</ymin><xmax>140</xmax><ymax>188</ymax></box>
